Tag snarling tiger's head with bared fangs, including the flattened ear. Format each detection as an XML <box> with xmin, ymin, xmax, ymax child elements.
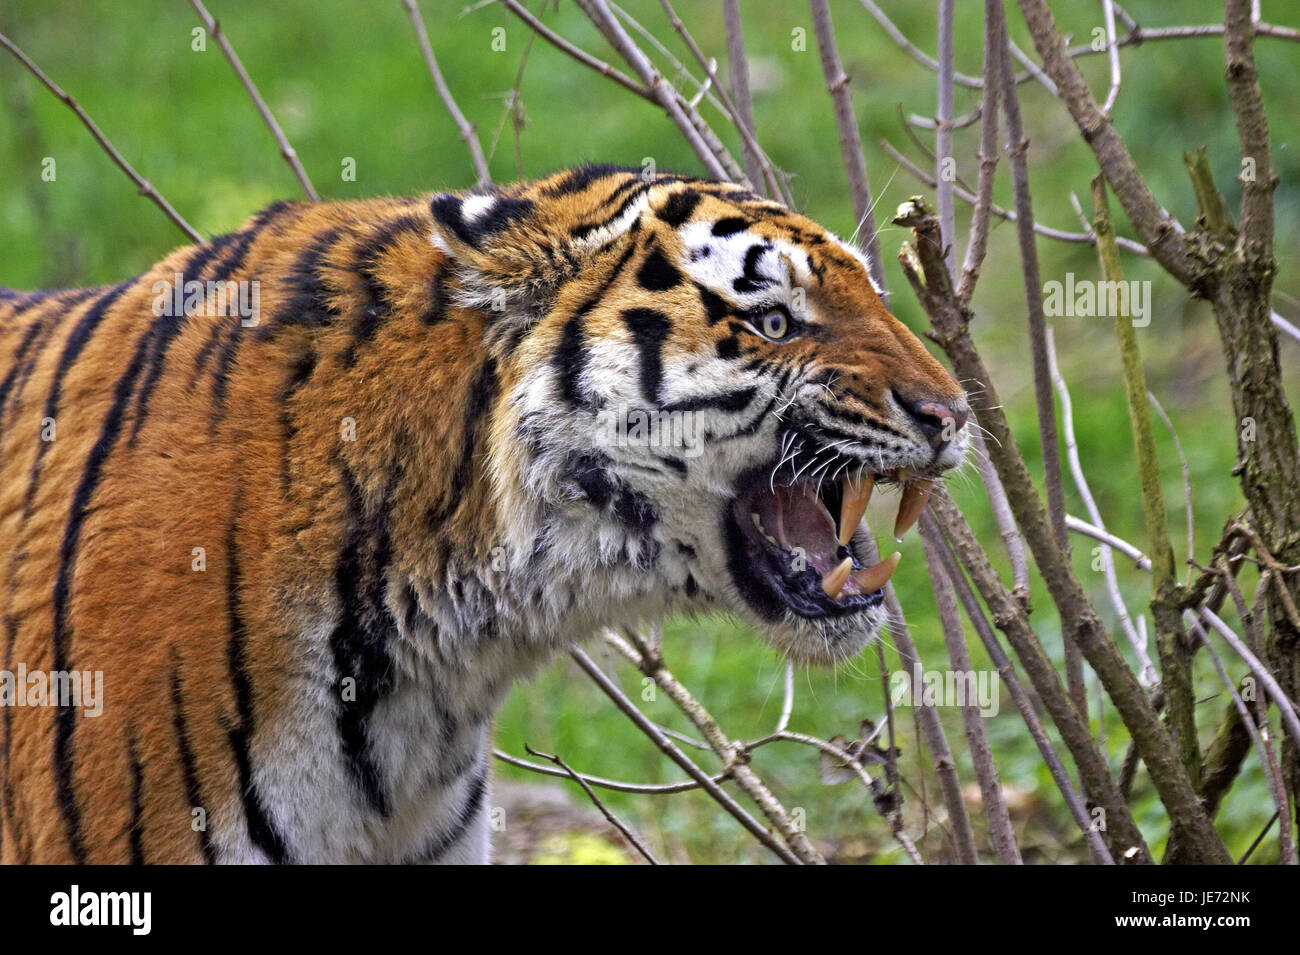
<box><xmin>432</xmin><ymin>166</ymin><xmax>970</xmax><ymax>663</ymax></box>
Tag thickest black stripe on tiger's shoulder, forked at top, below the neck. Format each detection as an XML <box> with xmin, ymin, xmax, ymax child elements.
<box><xmin>330</xmin><ymin>466</ymin><xmax>400</xmax><ymax>816</ymax></box>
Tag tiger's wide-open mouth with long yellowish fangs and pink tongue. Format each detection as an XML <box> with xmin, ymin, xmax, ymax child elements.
<box><xmin>728</xmin><ymin>469</ymin><xmax>932</xmax><ymax>620</ymax></box>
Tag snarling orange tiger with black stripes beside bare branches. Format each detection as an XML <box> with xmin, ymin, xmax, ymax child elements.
<box><xmin>0</xmin><ymin>164</ymin><xmax>970</xmax><ymax>864</ymax></box>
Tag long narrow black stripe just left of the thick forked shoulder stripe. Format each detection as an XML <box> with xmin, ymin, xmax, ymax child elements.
<box><xmin>226</xmin><ymin>511</ymin><xmax>289</xmax><ymax>863</ymax></box>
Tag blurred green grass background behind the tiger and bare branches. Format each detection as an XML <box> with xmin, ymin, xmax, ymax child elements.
<box><xmin>0</xmin><ymin>0</ymin><xmax>1300</xmax><ymax>863</ymax></box>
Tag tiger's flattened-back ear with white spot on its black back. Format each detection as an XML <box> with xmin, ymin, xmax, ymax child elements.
<box><xmin>429</xmin><ymin>180</ymin><xmax>645</xmax><ymax>314</ymax></box>
